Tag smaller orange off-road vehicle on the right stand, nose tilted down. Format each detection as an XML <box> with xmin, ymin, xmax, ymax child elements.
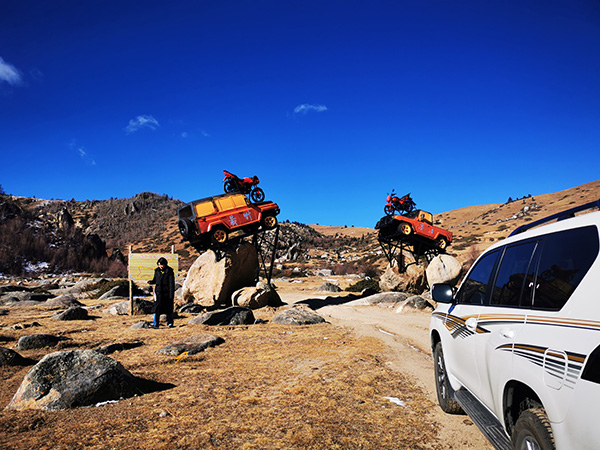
<box><xmin>375</xmin><ymin>209</ymin><xmax>452</xmax><ymax>252</ymax></box>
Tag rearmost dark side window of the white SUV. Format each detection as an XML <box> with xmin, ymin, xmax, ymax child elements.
<box><xmin>533</xmin><ymin>226</ymin><xmax>599</xmax><ymax>310</ymax></box>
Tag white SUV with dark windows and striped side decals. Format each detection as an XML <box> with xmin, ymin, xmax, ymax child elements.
<box><xmin>430</xmin><ymin>200</ymin><xmax>600</xmax><ymax>450</ymax></box>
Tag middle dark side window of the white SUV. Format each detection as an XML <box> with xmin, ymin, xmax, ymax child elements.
<box><xmin>490</xmin><ymin>241</ymin><xmax>537</xmax><ymax>306</ymax></box>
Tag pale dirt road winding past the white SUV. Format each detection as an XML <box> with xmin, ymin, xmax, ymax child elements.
<box><xmin>282</xmin><ymin>294</ymin><xmax>494</xmax><ymax>449</ymax></box>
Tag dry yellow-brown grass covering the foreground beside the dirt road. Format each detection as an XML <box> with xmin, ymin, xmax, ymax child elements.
<box><xmin>0</xmin><ymin>300</ymin><xmax>444</xmax><ymax>449</ymax></box>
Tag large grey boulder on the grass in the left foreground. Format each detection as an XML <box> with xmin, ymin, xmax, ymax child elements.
<box><xmin>6</xmin><ymin>350</ymin><xmax>139</xmax><ymax>411</ymax></box>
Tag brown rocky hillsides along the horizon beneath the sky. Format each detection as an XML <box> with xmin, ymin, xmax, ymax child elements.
<box><xmin>0</xmin><ymin>180</ymin><xmax>600</xmax><ymax>276</ymax></box>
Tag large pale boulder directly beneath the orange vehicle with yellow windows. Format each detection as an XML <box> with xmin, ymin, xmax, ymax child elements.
<box><xmin>183</xmin><ymin>242</ymin><xmax>259</xmax><ymax>306</ymax></box>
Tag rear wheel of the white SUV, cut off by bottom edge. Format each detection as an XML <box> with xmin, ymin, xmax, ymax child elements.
<box><xmin>512</xmin><ymin>408</ymin><xmax>556</xmax><ymax>450</ymax></box>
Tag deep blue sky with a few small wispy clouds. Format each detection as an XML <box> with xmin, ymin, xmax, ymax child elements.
<box><xmin>0</xmin><ymin>0</ymin><xmax>600</xmax><ymax>227</ymax></box>
